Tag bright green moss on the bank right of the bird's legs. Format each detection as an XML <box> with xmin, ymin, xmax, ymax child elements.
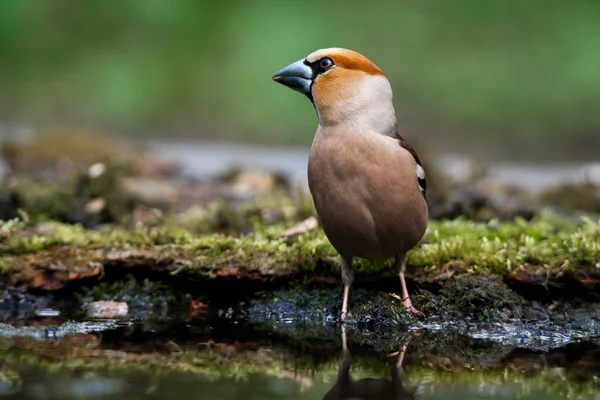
<box><xmin>408</xmin><ymin>214</ymin><xmax>600</xmax><ymax>274</ymax></box>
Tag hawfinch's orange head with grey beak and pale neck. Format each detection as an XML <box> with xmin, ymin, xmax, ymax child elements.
<box><xmin>273</xmin><ymin>48</ymin><xmax>396</xmax><ymax>135</ymax></box>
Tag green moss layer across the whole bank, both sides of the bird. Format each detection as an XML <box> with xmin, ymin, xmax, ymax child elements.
<box><xmin>0</xmin><ymin>214</ymin><xmax>600</xmax><ymax>286</ymax></box>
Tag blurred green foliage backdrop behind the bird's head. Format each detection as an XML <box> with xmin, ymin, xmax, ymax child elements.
<box><xmin>0</xmin><ymin>0</ymin><xmax>600</xmax><ymax>159</ymax></box>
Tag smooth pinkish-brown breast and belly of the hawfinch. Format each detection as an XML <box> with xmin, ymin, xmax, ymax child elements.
<box><xmin>308</xmin><ymin>128</ymin><xmax>427</xmax><ymax>259</ymax></box>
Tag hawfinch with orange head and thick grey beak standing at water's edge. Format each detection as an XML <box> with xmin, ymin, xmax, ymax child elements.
<box><xmin>273</xmin><ymin>48</ymin><xmax>428</xmax><ymax>319</ymax></box>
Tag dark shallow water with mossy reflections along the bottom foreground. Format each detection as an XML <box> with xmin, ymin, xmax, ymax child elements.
<box><xmin>0</xmin><ymin>318</ymin><xmax>600</xmax><ymax>400</ymax></box>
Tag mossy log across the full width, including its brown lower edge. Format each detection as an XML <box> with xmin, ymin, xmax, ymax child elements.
<box><xmin>0</xmin><ymin>209</ymin><xmax>600</xmax><ymax>297</ymax></box>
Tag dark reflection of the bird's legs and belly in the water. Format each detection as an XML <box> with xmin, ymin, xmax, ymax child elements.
<box><xmin>323</xmin><ymin>327</ymin><xmax>415</xmax><ymax>400</ymax></box>
